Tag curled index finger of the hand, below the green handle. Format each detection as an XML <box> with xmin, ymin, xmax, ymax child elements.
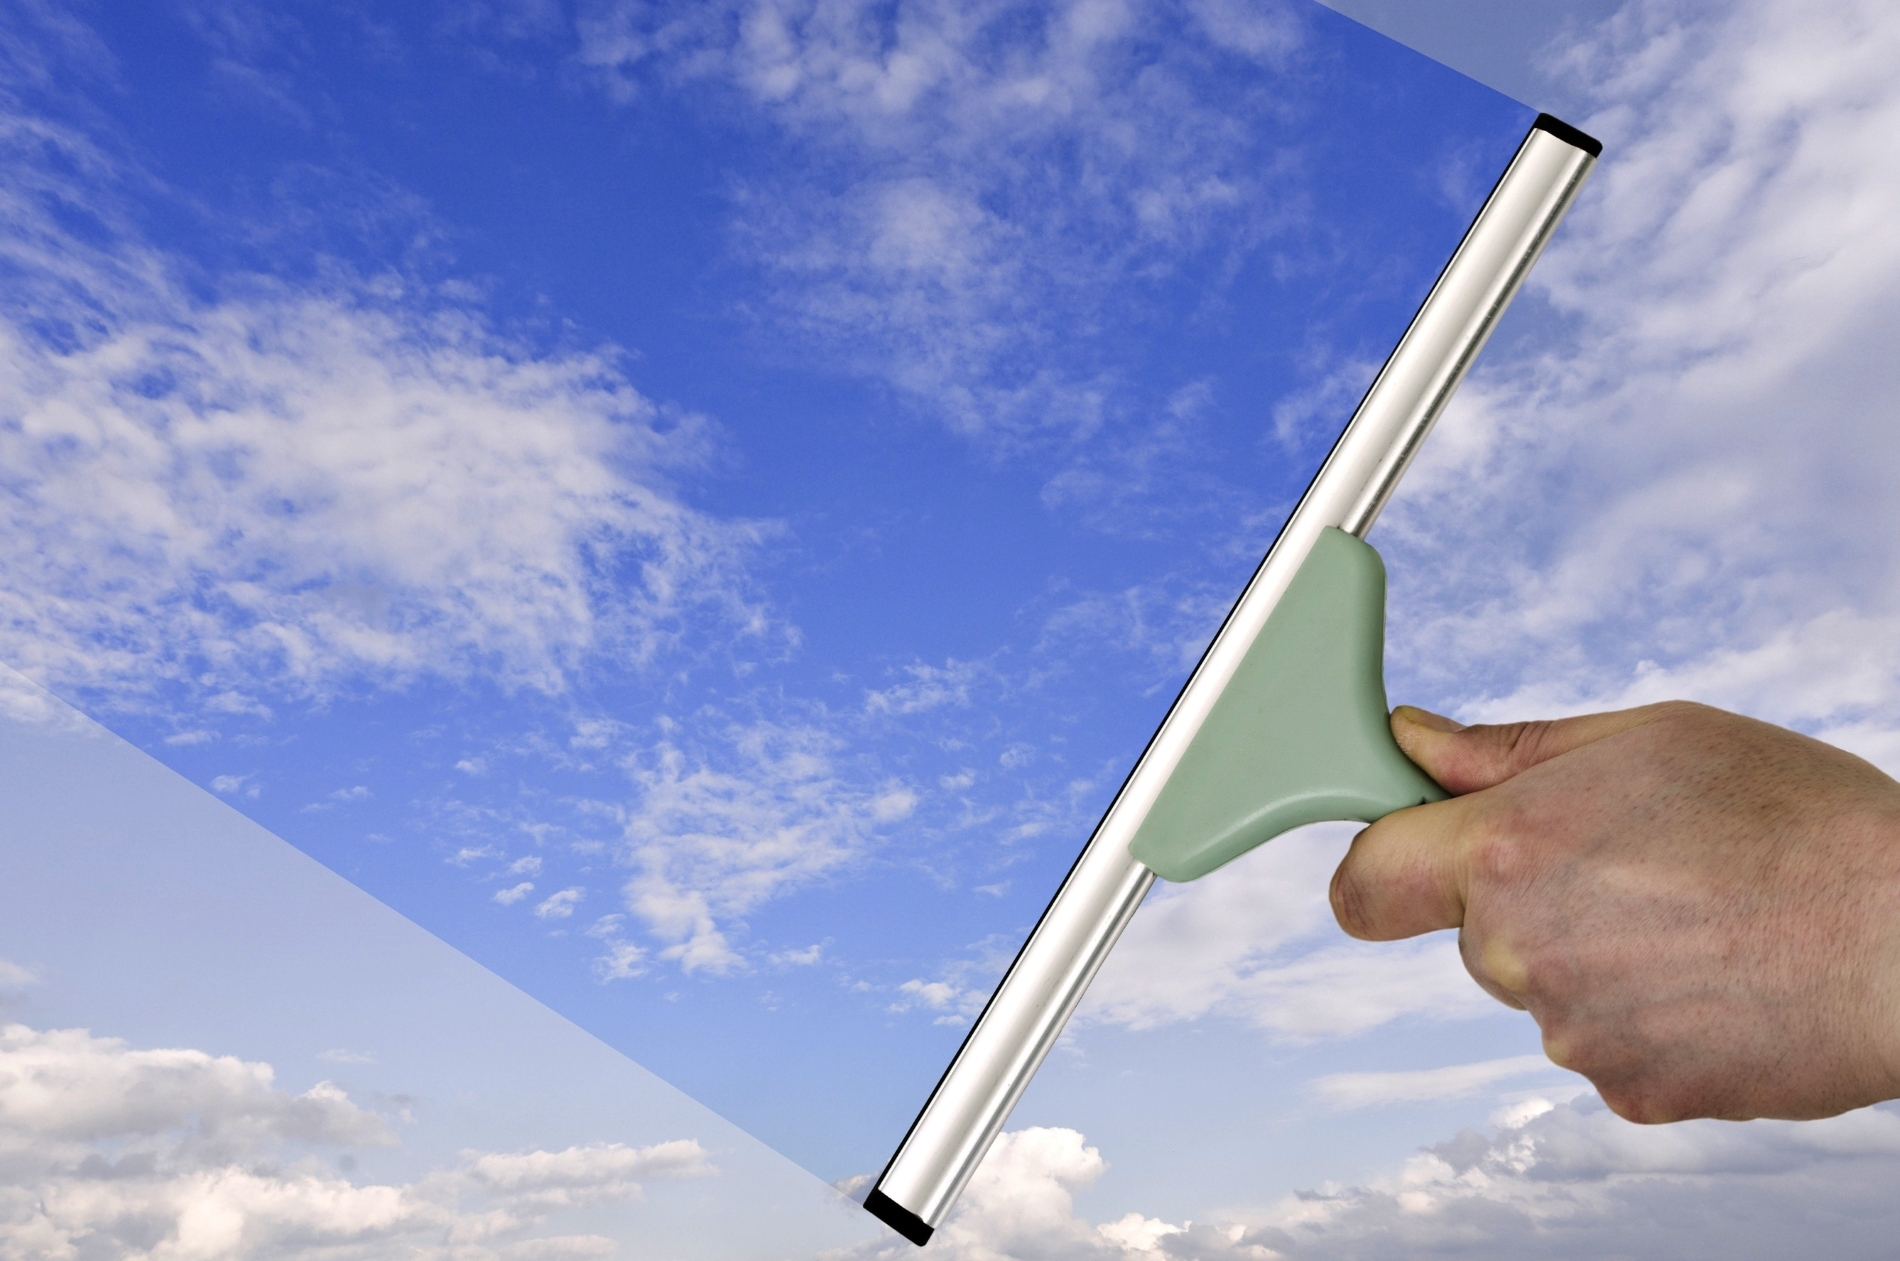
<box><xmin>1332</xmin><ymin>796</ymin><xmax>1478</xmax><ymax>942</ymax></box>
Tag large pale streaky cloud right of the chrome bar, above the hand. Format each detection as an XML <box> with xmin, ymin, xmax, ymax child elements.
<box><xmin>1376</xmin><ymin>0</ymin><xmax>1900</xmax><ymax>746</ymax></box>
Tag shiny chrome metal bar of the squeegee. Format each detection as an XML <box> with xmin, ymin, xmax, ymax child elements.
<box><xmin>876</xmin><ymin>120</ymin><xmax>1594</xmax><ymax>1227</ymax></box>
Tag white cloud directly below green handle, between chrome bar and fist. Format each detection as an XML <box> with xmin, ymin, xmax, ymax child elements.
<box><xmin>1077</xmin><ymin>824</ymin><xmax>1497</xmax><ymax>1043</ymax></box>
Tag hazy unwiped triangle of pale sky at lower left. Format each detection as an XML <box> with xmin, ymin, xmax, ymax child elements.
<box><xmin>0</xmin><ymin>683</ymin><xmax>878</xmax><ymax>1259</ymax></box>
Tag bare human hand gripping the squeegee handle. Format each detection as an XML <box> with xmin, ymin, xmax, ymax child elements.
<box><xmin>1332</xmin><ymin>701</ymin><xmax>1900</xmax><ymax>1122</ymax></box>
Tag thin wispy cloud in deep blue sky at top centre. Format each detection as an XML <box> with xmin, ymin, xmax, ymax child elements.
<box><xmin>580</xmin><ymin>0</ymin><xmax>1330</xmax><ymax>472</ymax></box>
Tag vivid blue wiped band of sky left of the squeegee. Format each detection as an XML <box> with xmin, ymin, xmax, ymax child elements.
<box><xmin>0</xmin><ymin>6</ymin><xmax>1528</xmax><ymax>1177</ymax></box>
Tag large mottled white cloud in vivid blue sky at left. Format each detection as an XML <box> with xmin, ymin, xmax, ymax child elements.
<box><xmin>0</xmin><ymin>103</ymin><xmax>764</xmax><ymax>716</ymax></box>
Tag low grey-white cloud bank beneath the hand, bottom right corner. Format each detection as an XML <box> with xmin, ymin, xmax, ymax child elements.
<box><xmin>1216</xmin><ymin>1096</ymin><xmax>1900</xmax><ymax>1261</ymax></box>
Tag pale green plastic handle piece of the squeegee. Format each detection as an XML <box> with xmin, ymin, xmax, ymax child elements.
<box><xmin>1129</xmin><ymin>528</ymin><xmax>1446</xmax><ymax>881</ymax></box>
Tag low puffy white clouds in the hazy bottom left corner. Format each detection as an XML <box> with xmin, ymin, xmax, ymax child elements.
<box><xmin>0</xmin><ymin>1026</ymin><xmax>718</xmax><ymax>1261</ymax></box>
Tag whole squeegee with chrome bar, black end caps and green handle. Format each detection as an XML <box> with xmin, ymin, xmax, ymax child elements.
<box><xmin>865</xmin><ymin>114</ymin><xmax>1602</xmax><ymax>1246</ymax></box>
